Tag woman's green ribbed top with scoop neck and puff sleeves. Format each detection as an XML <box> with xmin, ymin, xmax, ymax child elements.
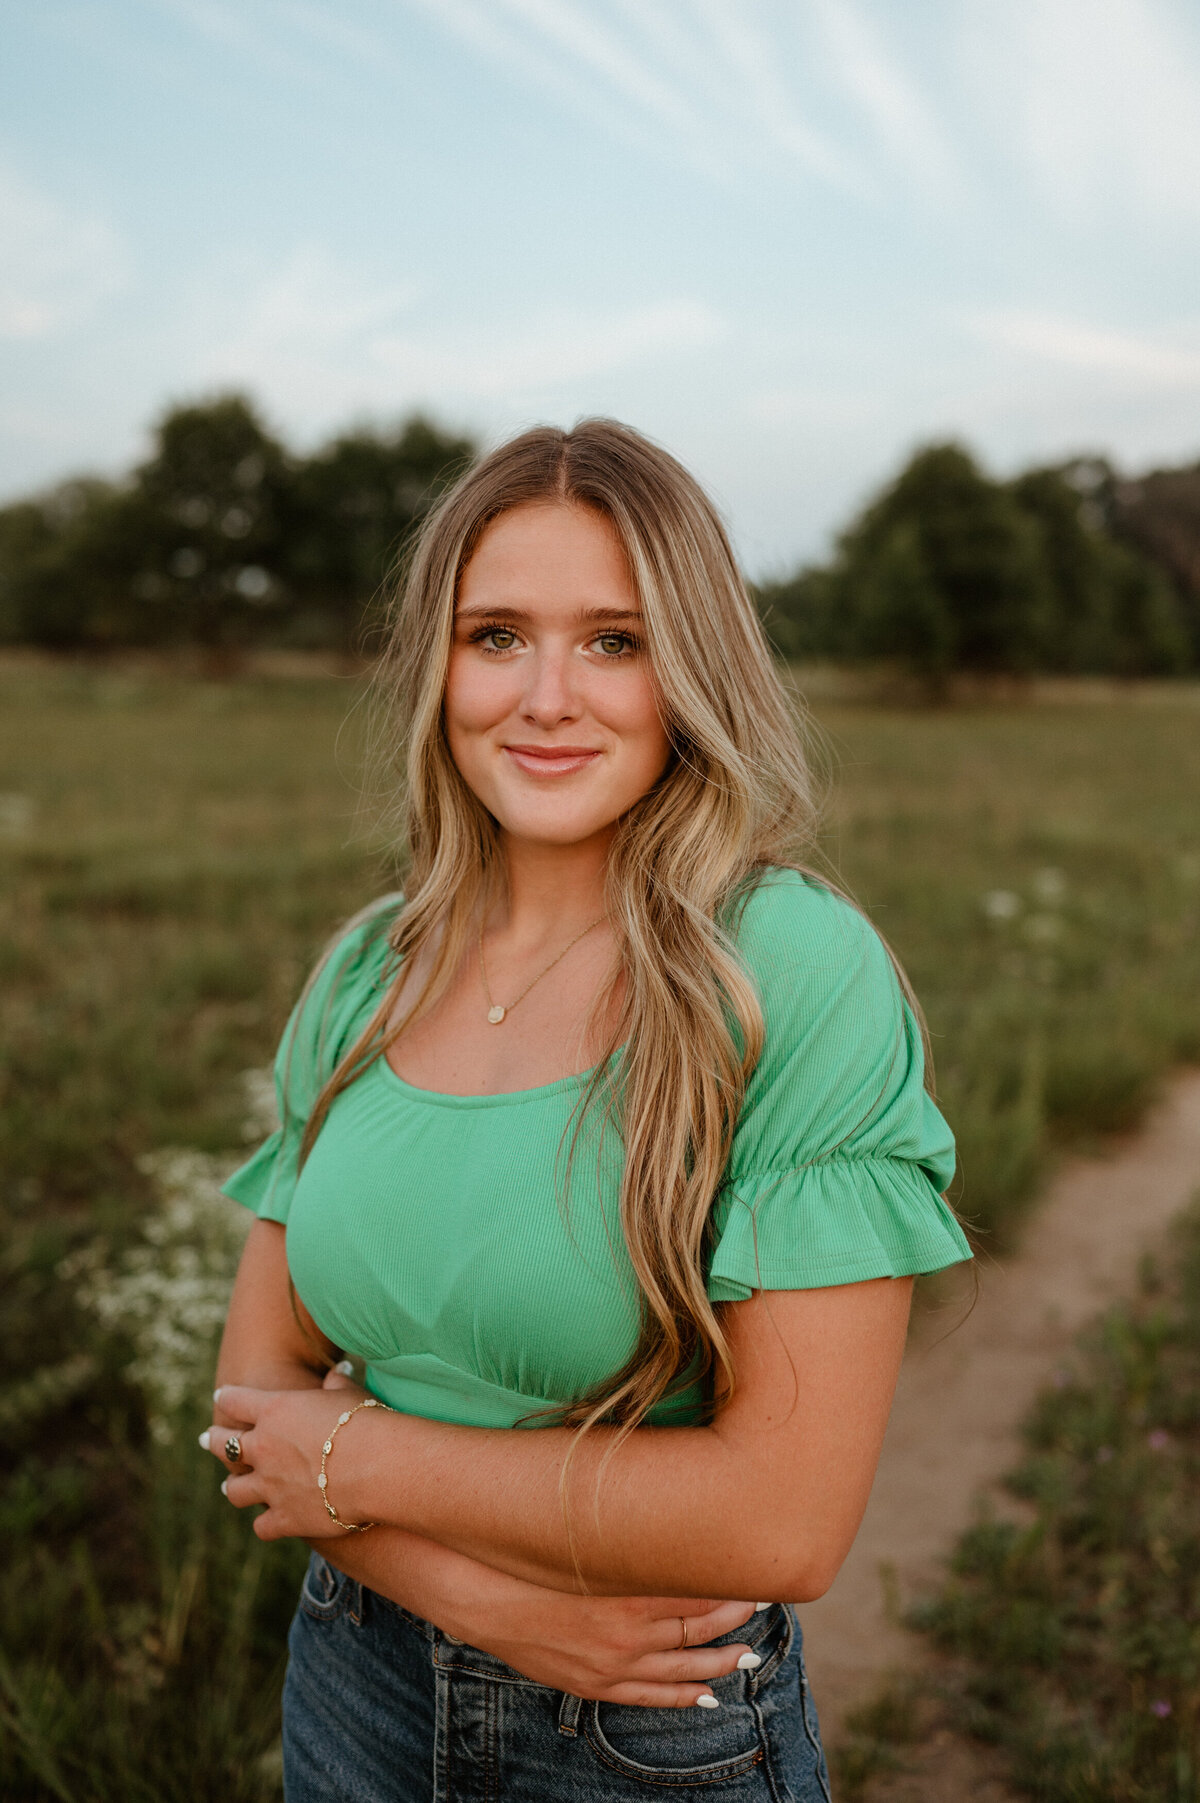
<box><xmin>225</xmin><ymin>869</ymin><xmax>971</xmax><ymax>1426</ymax></box>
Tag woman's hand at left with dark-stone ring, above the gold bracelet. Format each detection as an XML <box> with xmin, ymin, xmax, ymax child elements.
<box><xmin>200</xmin><ymin>1381</ymin><xmax>376</xmax><ymax>1540</ymax></box>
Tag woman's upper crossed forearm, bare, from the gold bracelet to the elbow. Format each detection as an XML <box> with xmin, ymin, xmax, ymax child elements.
<box><xmin>339</xmin><ymin>1417</ymin><xmax>821</xmax><ymax>1601</ymax></box>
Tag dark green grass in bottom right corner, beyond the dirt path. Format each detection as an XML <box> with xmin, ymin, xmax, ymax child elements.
<box><xmin>900</xmin><ymin>1204</ymin><xmax>1200</xmax><ymax>1803</ymax></box>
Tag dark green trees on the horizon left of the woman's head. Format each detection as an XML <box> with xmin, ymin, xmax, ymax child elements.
<box><xmin>0</xmin><ymin>395</ymin><xmax>476</xmax><ymax>653</ymax></box>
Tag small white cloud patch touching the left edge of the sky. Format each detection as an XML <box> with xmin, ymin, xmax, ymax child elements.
<box><xmin>0</xmin><ymin>166</ymin><xmax>128</xmax><ymax>339</ymax></box>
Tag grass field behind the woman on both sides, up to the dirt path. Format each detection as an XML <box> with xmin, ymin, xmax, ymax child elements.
<box><xmin>0</xmin><ymin>665</ymin><xmax>1200</xmax><ymax>1803</ymax></box>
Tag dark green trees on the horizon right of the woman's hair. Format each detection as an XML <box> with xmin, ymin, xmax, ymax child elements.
<box><xmin>759</xmin><ymin>444</ymin><xmax>1200</xmax><ymax>689</ymax></box>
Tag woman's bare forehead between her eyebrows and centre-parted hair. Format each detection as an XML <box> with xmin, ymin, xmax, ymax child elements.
<box><xmin>458</xmin><ymin>501</ymin><xmax>636</xmax><ymax>609</ymax></box>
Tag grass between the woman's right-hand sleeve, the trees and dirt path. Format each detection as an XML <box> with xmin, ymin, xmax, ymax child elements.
<box><xmin>803</xmin><ymin>698</ymin><xmax>1200</xmax><ymax>1248</ymax></box>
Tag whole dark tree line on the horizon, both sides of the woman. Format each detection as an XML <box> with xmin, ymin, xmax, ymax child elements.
<box><xmin>0</xmin><ymin>395</ymin><xmax>1200</xmax><ymax>689</ymax></box>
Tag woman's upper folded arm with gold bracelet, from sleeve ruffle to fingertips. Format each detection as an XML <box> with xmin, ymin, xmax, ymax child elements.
<box><xmin>222</xmin><ymin>1226</ymin><xmax>912</xmax><ymax>1601</ymax></box>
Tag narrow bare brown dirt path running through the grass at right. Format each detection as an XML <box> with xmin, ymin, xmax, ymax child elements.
<box><xmin>800</xmin><ymin>1071</ymin><xmax>1200</xmax><ymax>1759</ymax></box>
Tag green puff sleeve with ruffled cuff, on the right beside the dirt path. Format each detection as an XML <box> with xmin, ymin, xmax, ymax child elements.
<box><xmin>708</xmin><ymin>869</ymin><xmax>971</xmax><ymax>1302</ymax></box>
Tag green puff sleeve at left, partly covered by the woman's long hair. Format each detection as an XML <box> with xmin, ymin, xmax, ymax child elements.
<box><xmin>222</xmin><ymin>896</ymin><xmax>404</xmax><ymax>1222</ymax></box>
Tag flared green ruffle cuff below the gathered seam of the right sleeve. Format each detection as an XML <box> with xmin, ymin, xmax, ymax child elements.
<box><xmin>708</xmin><ymin>1156</ymin><xmax>971</xmax><ymax>1302</ymax></box>
